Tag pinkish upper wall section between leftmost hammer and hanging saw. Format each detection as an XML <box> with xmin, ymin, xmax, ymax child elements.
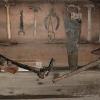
<box><xmin>10</xmin><ymin>3</ymin><xmax>65</xmax><ymax>40</ymax></box>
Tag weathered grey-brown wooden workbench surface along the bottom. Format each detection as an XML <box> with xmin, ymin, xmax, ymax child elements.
<box><xmin>0</xmin><ymin>71</ymin><xmax>100</xmax><ymax>99</ymax></box>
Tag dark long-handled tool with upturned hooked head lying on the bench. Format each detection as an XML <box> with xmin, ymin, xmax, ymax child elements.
<box><xmin>0</xmin><ymin>54</ymin><xmax>54</xmax><ymax>79</ymax></box>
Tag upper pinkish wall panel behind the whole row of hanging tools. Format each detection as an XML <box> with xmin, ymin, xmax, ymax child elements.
<box><xmin>0</xmin><ymin>3</ymin><xmax>100</xmax><ymax>41</ymax></box>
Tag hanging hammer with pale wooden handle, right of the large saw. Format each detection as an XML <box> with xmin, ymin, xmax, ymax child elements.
<box><xmin>85</xmin><ymin>4</ymin><xmax>94</xmax><ymax>41</ymax></box>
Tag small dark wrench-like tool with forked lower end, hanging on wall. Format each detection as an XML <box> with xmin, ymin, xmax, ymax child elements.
<box><xmin>18</xmin><ymin>10</ymin><xmax>25</xmax><ymax>35</ymax></box>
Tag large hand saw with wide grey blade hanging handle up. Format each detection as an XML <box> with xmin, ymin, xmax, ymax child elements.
<box><xmin>64</xmin><ymin>5</ymin><xmax>81</xmax><ymax>70</ymax></box>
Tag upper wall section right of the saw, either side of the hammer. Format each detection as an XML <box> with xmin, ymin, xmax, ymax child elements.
<box><xmin>80</xmin><ymin>7</ymin><xmax>100</xmax><ymax>42</ymax></box>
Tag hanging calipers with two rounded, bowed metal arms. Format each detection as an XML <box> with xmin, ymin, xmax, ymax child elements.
<box><xmin>44</xmin><ymin>8</ymin><xmax>60</xmax><ymax>41</ymax></box>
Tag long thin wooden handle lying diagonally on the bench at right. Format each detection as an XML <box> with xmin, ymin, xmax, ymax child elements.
<box><xmin>53</xmin><ymin>58</ymin><xmax>100</xmax><ymax>83</ymax></box>
